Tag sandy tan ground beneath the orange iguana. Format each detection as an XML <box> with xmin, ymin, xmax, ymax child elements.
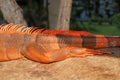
<box><xmin>0</xmin><ymin>48</ymin><xmax>120</xmax><ymax>80</ymax></box>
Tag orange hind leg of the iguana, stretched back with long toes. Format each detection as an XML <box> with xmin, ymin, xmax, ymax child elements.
<box><xmin>22</xmin><ymin>45</ymin><xmax>110</xmax><ymax>63</ymax></box>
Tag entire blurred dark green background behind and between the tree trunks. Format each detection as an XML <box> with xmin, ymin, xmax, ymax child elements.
<box><xmin>0</xmin><ymin>0</ymin><xmax>120</xmax><ymax>35</ymax></box>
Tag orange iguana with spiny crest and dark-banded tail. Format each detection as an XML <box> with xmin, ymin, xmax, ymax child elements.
<box><xmin>0</xmin><ymin>24</ymin><xmax>120</xmax><ymax>63</ymax></box>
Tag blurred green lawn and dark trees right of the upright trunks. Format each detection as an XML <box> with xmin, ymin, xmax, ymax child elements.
<box><xmin>70</xmin><ymin>0</ymin><xmax>120</xmax><ymax>35</ymax></box>
